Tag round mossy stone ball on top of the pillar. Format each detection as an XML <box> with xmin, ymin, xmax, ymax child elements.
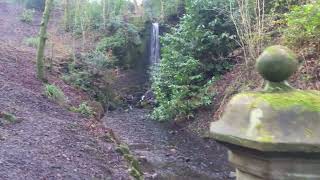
<box><xmin>256</xmin><ymin>45</ymin><xmax>298</xmax><ymax>82</ymax></box>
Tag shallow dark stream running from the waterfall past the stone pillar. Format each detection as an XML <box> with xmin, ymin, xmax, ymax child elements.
<box><xmin>103</xmin><ymin>109</ymin><xmax>232</xmax><ymax>180</ymax></box>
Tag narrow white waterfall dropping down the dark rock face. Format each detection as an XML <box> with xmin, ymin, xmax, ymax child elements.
<box><xmin>149</xmin><ymin>23</ymin><xmax>160</xmax><ymax>66</ymax></box>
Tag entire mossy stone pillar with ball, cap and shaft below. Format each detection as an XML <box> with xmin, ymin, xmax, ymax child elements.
<box><xmin>210</xmin><ymin>46</ymin><xmax>320</xmax><ymax>180</ymax></box>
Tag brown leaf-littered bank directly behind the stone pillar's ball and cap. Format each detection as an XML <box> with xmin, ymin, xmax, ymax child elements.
<box><xmin>188</xmin><ymin>42</ymin><xmax>320</xmax><ymax>135</ymax></box>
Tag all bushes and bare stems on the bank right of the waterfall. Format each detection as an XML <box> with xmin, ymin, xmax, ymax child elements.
<box><xmin>152</xmin><ymin>0</ymin><xmax>320</xmax><ymax>121</ymax></box>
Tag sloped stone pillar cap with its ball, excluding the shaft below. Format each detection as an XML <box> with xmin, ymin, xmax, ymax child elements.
<box><xmin>210</xmin><ymin>46</ymin><xmax>320</xmax><ymax>152</ymax></box>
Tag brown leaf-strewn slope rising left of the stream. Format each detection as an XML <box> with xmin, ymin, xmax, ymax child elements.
<box><xmin>0</xmin><ymin>1</ymin><xmax>130</xmax><ymax>180</ymax></box>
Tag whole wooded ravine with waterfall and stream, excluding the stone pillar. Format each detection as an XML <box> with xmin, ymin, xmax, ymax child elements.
<box><xmin>0</xmin><ymin>0</ymin><xmax>320</xmax><ymax>180</ymax></box>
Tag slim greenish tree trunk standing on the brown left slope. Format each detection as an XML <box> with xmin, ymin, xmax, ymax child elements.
<box><xmin>37</xmin><ymin>0</ymin><xmax>53</xmax><ymax>81</ymax></box>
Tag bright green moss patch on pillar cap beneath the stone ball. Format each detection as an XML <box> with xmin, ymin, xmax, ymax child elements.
<box><xmin>237</xmin><ymin>90</ymin><xmax>320</xmax><ymax>112</ymax></box>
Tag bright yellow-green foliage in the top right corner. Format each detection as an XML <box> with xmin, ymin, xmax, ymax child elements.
<box><xmin>284</xmin><ymin>1</ymin><xmax>320</xmax><ymax>45</ymax></box>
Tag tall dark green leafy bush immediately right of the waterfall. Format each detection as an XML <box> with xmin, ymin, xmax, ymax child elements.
<box><xmin>152</xmin><ymin>0</ymin><xmax>235</xmax><ymax>121</ymax></box>
